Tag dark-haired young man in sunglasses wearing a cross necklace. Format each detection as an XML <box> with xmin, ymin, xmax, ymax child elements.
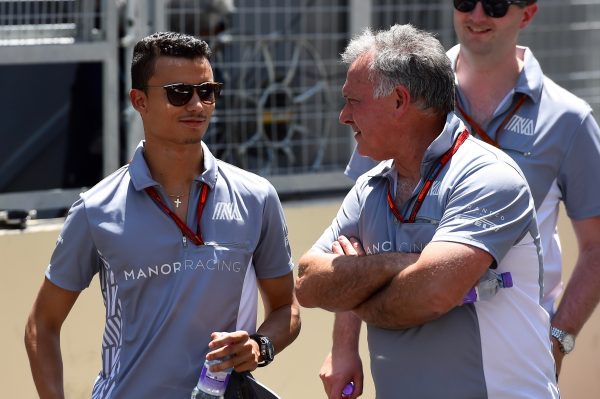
<box><xmin>25</xmin><ymin>32</ymin><xmax>300</xmax><ymax>399</ymax></box>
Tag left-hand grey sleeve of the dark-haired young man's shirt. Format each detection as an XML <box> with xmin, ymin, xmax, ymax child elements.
<box><xmin>46</xmin><ymin>199</ymin><xmax>100</xmax><ymax>291</ymax></box>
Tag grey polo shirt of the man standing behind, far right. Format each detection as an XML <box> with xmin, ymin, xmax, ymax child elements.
<box><xmin>345</xmin><ymin>45</ymin><xmax>600</xmax><ymax>313</ymax></box>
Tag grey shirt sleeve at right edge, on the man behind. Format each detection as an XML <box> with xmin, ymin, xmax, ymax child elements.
<box><xmin>556</xmin><ymin>114</ymin><xmax>600</xmax><ymax>220</ymax></box>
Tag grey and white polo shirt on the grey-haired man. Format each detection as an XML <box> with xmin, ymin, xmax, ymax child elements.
<box><xmin>315</xmin><ymin>114</ymin><xmax>558</xmax><ymax>399</ymax></box>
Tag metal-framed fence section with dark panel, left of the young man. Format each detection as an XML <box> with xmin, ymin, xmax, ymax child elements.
<box><xmin>0</xmin><ymin>0</ymin><xmax>121</xmax><ymax>214</ymax></box>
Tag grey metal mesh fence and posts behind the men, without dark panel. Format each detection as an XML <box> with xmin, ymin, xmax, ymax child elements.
<box><xmin>0</xmin><ymin>0</ymin><xmax>600</xmax><ymax>216</ymax></box>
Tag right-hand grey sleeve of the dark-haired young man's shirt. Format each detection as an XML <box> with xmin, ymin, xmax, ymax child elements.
<box><xmin>253</xmin><ymin>184</ymin><xmax>294</xmax><ymax>278</ymax></box>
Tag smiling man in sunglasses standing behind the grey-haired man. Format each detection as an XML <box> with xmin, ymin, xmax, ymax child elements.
<box><xmin>346</xmin><ymin>0</ymin><xmax>600</xmax><ymax>382</ymax></box>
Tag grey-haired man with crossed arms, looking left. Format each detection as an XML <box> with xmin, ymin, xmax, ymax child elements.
<box><xmin>296</xmin><ymin>25</ymin><xmax>558</xmax><ymax>399</ymax></box>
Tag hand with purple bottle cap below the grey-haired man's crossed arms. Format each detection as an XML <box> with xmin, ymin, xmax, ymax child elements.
<box><xmin>319</xmin><ymin>351</ymin><xmax>363</xmax><ymax>399</ymax></box>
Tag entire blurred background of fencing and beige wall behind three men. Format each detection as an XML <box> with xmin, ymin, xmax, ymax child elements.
<box><xmin>0</xmin><ymin>0</ymin><xmax>600</xmax><ymax>398</ymax></box>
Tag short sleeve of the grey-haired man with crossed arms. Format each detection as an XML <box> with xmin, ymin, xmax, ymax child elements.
<box><xmin>432</xmin><ymin>162</ymin><xmax>538</xmax><ymax>263</ymax></box>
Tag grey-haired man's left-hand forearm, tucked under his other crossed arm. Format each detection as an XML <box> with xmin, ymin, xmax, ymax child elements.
<box><xmin>296</xmin><ymin>251</ymin><xmax>418</xmax><ymax>312</ymax></box>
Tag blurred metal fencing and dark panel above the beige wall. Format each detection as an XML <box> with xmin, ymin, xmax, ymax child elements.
<box><xmin>0</xmin><ymin>0</ymin><xmax>600</xmax><ymax>218</ymax></box>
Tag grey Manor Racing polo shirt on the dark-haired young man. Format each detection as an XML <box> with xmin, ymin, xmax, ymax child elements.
<box><xmin>46</xmin><ymin>143</ymin><xmax>293</xmax><ymax>399</ymax></box>
